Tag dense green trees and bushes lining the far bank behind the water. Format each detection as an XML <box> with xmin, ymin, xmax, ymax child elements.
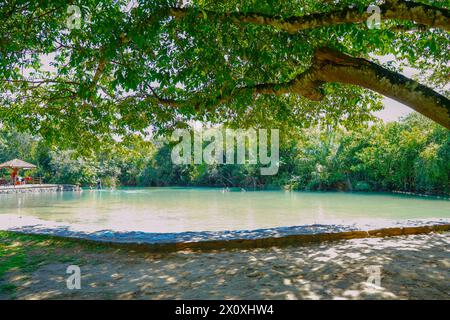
<box><xmin>0</xmin><ymin>114</ymin><xmax>450</xmax><ymax>194</ymax></box>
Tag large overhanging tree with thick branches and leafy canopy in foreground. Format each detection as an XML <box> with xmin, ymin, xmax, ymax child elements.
<box><xmin>0</xmin><ymin>0</ymin><xmax>450</xmax><ymax>148</ymax></box>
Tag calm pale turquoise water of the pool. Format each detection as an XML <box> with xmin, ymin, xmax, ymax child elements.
<box><xmin>0</xmin><ymin>188</ymin><xmax>450</xmax><ymax>233</ymax></box>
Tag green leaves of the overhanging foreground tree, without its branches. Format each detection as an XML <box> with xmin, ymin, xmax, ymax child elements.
<box><xmin>0</xmin><ymin>0</ymin><xmax>450</xmax><ymax>150</ymax></box>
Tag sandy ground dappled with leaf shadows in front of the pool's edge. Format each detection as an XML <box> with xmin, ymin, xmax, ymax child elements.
<box><xmin>0</xmin><ymin>232</ymin><xmax>450</xmax><ymax>299</ymax></box>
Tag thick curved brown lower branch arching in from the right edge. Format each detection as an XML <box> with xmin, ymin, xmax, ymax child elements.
<box><xmin>142</xmin><ymin>48</ymin><xmax>450</xmax><ymax>129</ymax></box>
